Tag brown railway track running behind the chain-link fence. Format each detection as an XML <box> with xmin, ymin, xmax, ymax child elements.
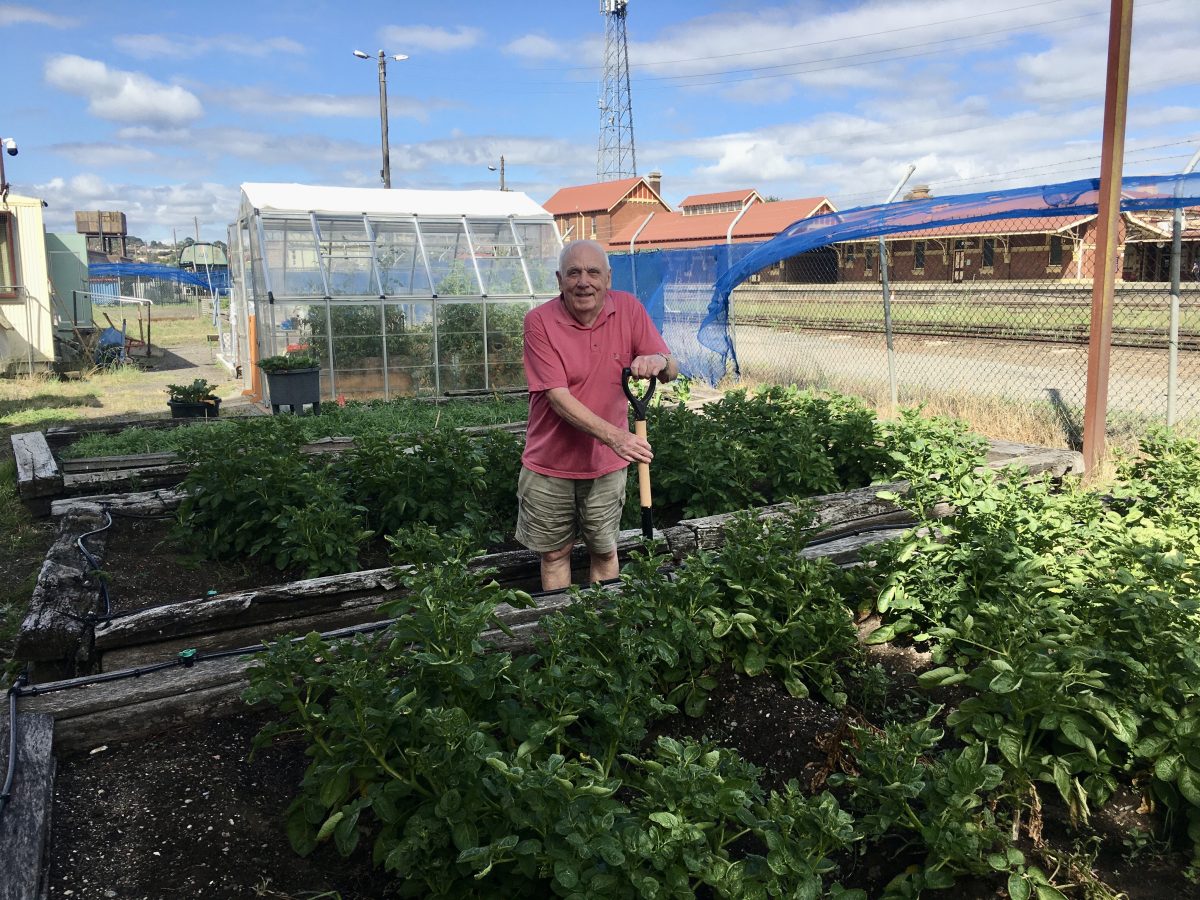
<box><xmin>736</xmin><ymin>314</ymin><xmax>1200</xmax><ymax>350</ymax></box>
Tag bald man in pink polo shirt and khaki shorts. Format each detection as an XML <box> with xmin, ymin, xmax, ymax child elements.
<box><xmin>516</xmin><ymin>241</ymin><xmax>679</xmax><ymax>590</ymax></box>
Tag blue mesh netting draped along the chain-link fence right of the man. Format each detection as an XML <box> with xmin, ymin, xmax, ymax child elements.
<box><xmin>610</xmin><ymin>173</ymin><xmax>1200</xmax><ymax>384</ymax></box>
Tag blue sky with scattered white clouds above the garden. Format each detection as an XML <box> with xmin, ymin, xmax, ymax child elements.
<box><xmin>0</xmin><ymin>0</ymin><xmax>1200</xmax><ymax>241</ymax></box>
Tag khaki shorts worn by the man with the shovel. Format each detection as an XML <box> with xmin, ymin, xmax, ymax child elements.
<box><xmin>516</xmin><ymin>466</ymin><xmax>629</xmax><ymax>553</ymax></box>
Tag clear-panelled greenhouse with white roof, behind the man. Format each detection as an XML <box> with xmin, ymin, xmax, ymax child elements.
<box><xmin>227</xmin><ymin>184</ymin><xmax>562</xmax><ymax>400</ymax></box>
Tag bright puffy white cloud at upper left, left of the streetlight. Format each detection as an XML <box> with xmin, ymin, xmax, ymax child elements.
<box><xmin>46</xmin><ymin>55</ymin><xmax>204</xmax><ymax>125</ymax></box>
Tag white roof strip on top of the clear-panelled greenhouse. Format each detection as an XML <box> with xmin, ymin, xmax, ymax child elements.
<box><xmin>241</xmin><ymin>182</ymin><xmax>553</xmax><ymax>220</ymax></box>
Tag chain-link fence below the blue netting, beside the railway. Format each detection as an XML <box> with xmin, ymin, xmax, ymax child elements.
<box><xmin>730</xmin><ymin>224</ymin><xmax>1200</xmax><ymax>446</ymax></box>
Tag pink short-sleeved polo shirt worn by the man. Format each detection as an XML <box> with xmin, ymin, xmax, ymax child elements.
<box><xmin>521</xmin><ymin>290</ymin><xmax>668</xmax><ymax>479</ymax></box>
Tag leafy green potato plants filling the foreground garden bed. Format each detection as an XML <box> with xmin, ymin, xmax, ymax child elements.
<box><xmin>247</xmin><ymin>432</ymin><xmax>1200</xmax><ymax>900</ymax></box>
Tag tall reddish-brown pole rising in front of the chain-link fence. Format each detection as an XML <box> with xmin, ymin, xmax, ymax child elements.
<box><xmin>1084</xmin><ymin>0</ymin><xmax>1133</xmax><ymax>473</ymax></box>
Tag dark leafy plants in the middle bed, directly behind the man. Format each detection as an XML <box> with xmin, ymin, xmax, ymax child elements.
<box><xmin>169</xmin><ymin>388</ymin><xmax>950</xmax><ymax>575</ymax></box>
